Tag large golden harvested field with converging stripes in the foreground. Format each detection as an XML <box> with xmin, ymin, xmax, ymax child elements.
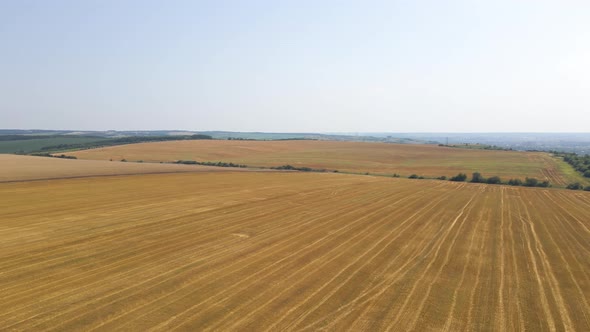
<box><xmin>0</xmin><ymin>172</ymin><xmax>590</xmax><ymax>331</ymax></box>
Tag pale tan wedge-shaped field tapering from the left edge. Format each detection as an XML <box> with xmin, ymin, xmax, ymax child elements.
<box><xmin>0</xmin><ymin>154</ymin><xmax>252</xmax><ymax>182</ymax></box>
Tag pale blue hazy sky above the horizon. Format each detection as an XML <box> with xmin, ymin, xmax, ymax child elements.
<box><xmin>0</xmin><ymin>0</ymin><xmax>590</xmax><ymax>132</ymax></box>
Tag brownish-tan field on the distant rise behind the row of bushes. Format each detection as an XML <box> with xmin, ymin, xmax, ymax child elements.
<box><xmin>69</xmin><ymin>140</ymin><xmax>579</xmax><ymax>185</ymax></box>
